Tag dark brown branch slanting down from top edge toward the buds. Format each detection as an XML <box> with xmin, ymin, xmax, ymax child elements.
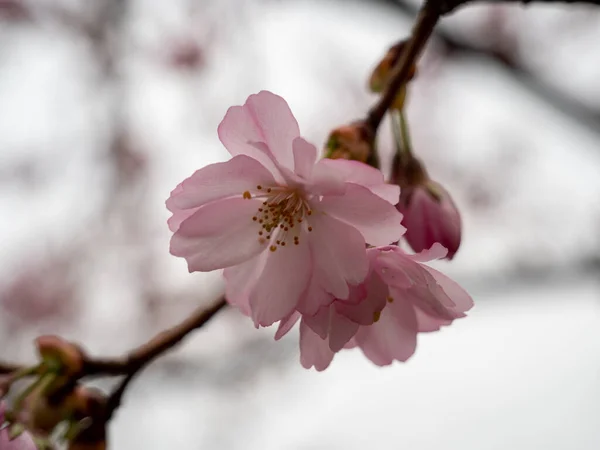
<box><xmin>365</xmin><ymin>0</ymin><xmax>442</xmax><ymax>136</ymax></box>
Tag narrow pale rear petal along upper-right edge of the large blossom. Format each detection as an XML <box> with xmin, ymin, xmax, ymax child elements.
<box><xmin>318</xmin><ymin>159</ymin><xmax>400</xmax><ymax>205</ymax></box>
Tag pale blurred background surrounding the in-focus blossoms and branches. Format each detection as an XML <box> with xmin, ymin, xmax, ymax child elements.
<box><xmin>0</xmin><ymin>0</ymin><xmax>600</xmax><ymax>450</ymax></box>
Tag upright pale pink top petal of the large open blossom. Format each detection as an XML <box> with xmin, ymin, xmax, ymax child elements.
<box><xmin>218</xmin><ymin>91</ymin><xmax>300</xmax><ymax>169</ymax></box>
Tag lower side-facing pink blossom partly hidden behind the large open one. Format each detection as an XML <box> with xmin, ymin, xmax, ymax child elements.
<box><xmin>275</xmin><ymin>244</ymin><xmax>473</xmax><ymax>371</ymax></box>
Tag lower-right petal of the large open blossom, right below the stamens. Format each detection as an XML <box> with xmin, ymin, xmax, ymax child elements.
<box><xmin>308</xmin><ymin>213</ymin><xmax>369</xmax><ymax>299</ymax></box>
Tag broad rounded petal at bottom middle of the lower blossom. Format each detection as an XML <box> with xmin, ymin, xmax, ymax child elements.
<box><xmin>354</xmin><ymin>299</ymin><xmax>417</xmax><ymax>366</ymax></box>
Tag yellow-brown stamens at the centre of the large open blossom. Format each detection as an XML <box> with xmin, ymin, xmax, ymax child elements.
<box><xmin>244</xmin><ymin>186</ymin><xmax>312</xmax><ymax>252</ymax></box>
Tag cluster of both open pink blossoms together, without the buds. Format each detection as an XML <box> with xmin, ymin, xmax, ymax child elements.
<box><xmin>167</xmin><ymin>91</ymin><xmax>472</xmax><ymax>370</ymax></box>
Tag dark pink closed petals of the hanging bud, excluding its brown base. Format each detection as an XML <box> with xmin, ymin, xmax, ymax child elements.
<box><xmin>397</xmin><ymin>181</ymin><xmax>461</xmax><ymax>259</ymax></box>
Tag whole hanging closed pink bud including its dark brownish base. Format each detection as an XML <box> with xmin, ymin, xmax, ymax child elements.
<box><xmin>392</xmin><ymin>155</ymin><xmax>462</xmax><ymax>259</ymax></box>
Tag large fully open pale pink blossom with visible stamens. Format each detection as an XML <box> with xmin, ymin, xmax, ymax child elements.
<box><xmin>167</xmin><ymin>91</ymin><xmax>404</xmax><ymax>326</ymax></box>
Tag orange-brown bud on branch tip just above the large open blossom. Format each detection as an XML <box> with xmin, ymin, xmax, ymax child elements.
<box><xmin>325</xmin><ymin>122</ymin><xmax>374</xmax><ymax>162</ymax></box>
